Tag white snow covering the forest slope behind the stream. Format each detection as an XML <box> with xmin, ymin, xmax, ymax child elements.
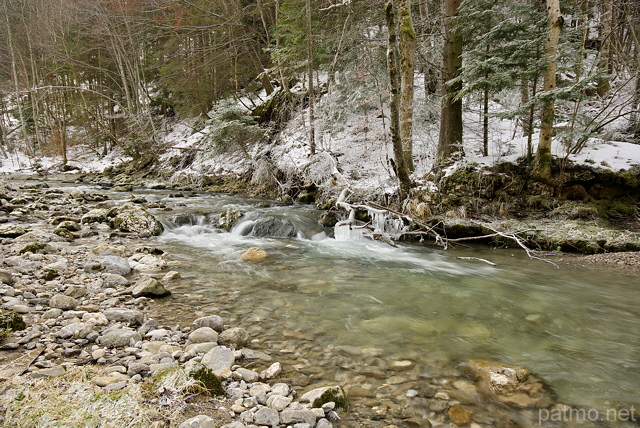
<box><xmin>0</xmin><ymin>92</ymin><xmax>640</xmax><ymax>189</ymax></box>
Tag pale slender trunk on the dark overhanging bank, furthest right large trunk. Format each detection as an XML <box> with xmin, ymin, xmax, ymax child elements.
<box><xmin>533</xmin><ymin>0</ymin><xmax>562</xmax><ymax>180</ymax></box>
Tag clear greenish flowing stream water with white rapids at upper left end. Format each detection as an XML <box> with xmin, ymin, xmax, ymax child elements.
<box><xmin>134</xmin><ymin>194</ymin><xmax>640</xmax><ymax>408</ymax></box>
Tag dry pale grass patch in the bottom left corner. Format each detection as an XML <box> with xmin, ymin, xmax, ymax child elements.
<box><xmin>0</xmin><ymin>367</ymin><xmax>216</xmax><ymax>428</ymax></box>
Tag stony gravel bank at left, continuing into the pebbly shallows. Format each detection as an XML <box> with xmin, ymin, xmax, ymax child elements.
<box><xmin>0</xmin><ymin>176</ymin><xmax>632</xmax><ymax>428</ymax></box>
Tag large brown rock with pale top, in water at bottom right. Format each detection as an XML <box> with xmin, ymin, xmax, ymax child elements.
<box><xmin>466</xmin><ymin>360</ymin><xmax>553</xmax><ymax>408</ymax></box>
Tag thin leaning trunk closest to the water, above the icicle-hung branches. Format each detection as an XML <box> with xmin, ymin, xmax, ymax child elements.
<box><xmin>385</xmin><ymin>0</ymin><xmax>411</xmax><ymax>201</ymax></box>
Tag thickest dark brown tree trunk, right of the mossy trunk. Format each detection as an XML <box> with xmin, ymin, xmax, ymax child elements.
<box><xmin>437</xmin><ymin>0</ymin><xmax>464</xmax><ymax>162</ymax></box>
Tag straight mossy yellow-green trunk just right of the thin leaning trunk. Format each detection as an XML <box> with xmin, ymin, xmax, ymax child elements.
<box><xmin>398</xmin><ymin>0</ymin><xmax>416</xmax><ymax>171</ymax></box>
